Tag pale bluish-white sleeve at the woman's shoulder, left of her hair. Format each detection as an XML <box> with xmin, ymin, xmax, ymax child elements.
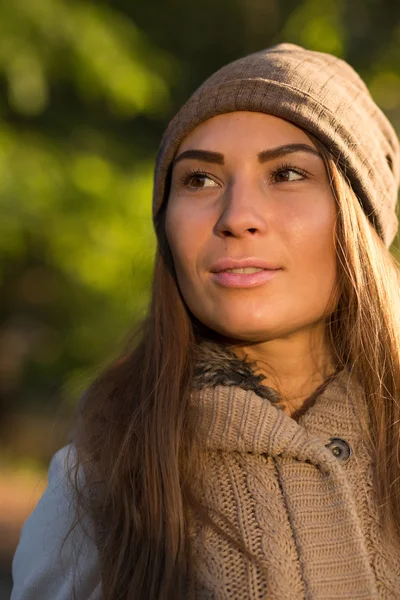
<box><xmin>11</xmin><ymin>445</ymin><xmax>101</xmax><ymax>600</ymax></box>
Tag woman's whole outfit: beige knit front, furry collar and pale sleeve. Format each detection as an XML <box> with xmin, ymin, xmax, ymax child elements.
<box><xmin>12</xmin><ymin>344</ymin><xmax>400</xmax><ymax>600</ymax></box>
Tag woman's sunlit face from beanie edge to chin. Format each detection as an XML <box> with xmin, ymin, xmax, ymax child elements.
<box><xmin>166</xmin><ymin>112</ymin><xmax>336</xmax><ymax>342</ymax></box>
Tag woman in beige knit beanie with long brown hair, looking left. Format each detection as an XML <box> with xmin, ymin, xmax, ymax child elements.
<box><xmin>12</xmin><ymin>44</ymin><xmax>400</xmax><ymax>600</ymax></box>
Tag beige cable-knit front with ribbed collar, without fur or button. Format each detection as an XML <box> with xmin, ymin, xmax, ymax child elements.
<box><xmin>191</xmin><ymin>370</ymin><xmax>400</xmax><ymax>600</ymax></box>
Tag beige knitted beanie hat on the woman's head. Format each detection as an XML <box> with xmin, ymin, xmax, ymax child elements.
<box><xmin>153</xmin><ymin>44</ymin><xmax>400</xmax><ymax>247</ymax></box>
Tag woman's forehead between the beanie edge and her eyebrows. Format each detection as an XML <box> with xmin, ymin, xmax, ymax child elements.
<box><xmin>178</xmin><ymin>111</ymin><xmax>315</xmax><ymax>153</ymax></box>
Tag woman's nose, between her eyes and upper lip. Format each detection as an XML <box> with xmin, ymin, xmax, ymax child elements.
<box><xmin>215</xmin><ymin>178</ymin><xmax>267</xmax><ymax>238</ymax></box>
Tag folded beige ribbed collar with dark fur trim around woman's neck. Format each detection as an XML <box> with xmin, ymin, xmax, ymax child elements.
<box><xmin>191</xmin><ymin>343</ymin><xmax>365</xmax><ymax>462</ymax></box>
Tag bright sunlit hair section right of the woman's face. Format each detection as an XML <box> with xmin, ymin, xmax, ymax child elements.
<box><xmin>317</xmin><ymin>138</ymin><xmax>400</xmax><ymax>542</ymax></box>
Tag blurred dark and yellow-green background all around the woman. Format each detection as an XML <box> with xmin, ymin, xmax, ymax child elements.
<box><xmin>0</xmin><ymin>0</ymin><xmax>400</xmax><ymax>598</ymax></box>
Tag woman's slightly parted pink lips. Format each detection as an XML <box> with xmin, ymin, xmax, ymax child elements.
<box><xmin>210</xmin><ymin>257</ymin><xmax>281</xmax><ymax>288</ymax></box>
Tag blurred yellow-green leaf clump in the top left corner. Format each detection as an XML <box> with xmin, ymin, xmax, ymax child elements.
<box><xmin>0</xmin><ymin>0</ymin><xmax>170</xmax><ymax>117</ymax></box>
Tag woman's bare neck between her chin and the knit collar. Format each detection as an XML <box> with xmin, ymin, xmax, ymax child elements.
<box><xmin>232</xmin><ymin>328</ymin><xmax>336</xmax><ymax>416</ymax></box>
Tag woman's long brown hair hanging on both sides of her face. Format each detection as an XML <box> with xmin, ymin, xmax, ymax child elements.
<box><xmin>65</xmin><ymin>140</ymin><xmax>400</xmax><ymax>600</ymax></box>
